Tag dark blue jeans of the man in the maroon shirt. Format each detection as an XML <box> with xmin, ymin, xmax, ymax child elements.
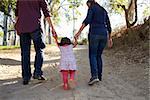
<box><xmin>20</xmin><ymin>29</ymin><xmax>45</xmax><ymax>80</ymax></box>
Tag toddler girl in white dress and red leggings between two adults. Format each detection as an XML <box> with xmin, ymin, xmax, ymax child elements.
<box><xmin>55</xmin><ymin>37</ymin><xmax>77</xmax><ymax>90</ymax></box>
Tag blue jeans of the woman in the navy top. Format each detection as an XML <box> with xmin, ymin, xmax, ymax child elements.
<box><xmin>88</xmin><ymin>34</ymin><xmax>107</xmax><ymax>79</ymax></box>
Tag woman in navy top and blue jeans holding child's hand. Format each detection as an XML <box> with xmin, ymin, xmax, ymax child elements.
<box><xmin>75</xmin><ymin>0</ymin><xmax>112</xmax><ymax>85</ymax></box>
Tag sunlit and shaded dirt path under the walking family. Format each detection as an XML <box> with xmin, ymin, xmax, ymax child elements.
<box><xmin>0</xmin><ymin>46</ymin><xmax>149</xmax><ymax>100</ymax></box>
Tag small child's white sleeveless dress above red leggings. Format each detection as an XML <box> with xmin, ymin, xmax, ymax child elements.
<box><xmin>59</xmin><ymin>45</ymin><xmax>77</xmax><ymax>70</ymax></box>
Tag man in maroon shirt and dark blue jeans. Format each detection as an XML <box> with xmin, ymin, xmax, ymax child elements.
<box><xmin>15</xmin><ymin>0</ymin><xmax>57</xmax><ymax>85</ymax></box>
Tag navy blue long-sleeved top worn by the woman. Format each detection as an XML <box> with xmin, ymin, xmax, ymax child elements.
<box><xmin>83</xmin><ymin>3</ymin><xmax>111</xmax><ymax>35</ymax></box>
